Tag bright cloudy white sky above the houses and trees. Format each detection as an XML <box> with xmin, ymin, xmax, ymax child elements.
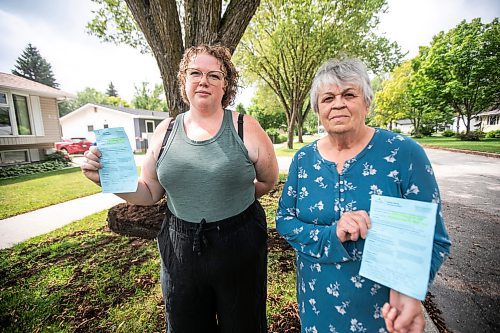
<box><xmin>0</xmin><ymin>0</ymin><xmax>500</xmax><ymax>105</ymax></box>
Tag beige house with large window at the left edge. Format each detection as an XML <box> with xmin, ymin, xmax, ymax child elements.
<box><xmin>0</xmin><ymin>72</ymin><xmax>75</xmax><ymax>166</ymax></box>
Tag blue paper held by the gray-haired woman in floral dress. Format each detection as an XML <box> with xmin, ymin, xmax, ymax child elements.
<box><xmin>359</xmin><ymin>195</ymin><xmax>437</xmax><ymax>301</ymax></box>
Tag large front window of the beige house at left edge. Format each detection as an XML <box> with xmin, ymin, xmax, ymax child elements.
<box><xmin>0</xmin><ymin>91</ymin><xmax>33</xmax><ymax>135</ymax></box>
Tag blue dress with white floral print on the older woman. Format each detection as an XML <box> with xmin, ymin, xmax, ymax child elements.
<box><xmin>276</xmin><ymin>129</ymin><xmax>451</xmax><ymax>333</ymax></box>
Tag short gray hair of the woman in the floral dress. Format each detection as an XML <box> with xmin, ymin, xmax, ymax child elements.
<box><xmin>310</xmin><ymin>59</ymin><xmax>373</xmax><ymax>113</ymax></box>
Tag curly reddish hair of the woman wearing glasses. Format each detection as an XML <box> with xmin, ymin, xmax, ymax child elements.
<box><xmin>177</xmin><ymin>44</ymin><xmax>239</xmax><ymax>108</ymax></box>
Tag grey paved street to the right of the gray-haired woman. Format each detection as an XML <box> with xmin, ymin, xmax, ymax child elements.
<box><xmin>426</xmin><ymin>149</ymin><xmax>500</xmax><ymax>333</ymax></box>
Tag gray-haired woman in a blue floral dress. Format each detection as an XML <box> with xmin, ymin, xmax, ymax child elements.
<box><xmin>276</xmin><ymin>59</ymin><xmax>451</xmax><ymax>333</ymax></box>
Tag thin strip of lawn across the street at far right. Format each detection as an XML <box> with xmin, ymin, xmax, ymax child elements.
<box><xmin>415</xmin><ymin>136</ymin><xmax>500</xmax><ymax>154</ymax></box>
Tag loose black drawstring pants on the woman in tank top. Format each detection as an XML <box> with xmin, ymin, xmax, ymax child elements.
<box><xmin>158</xmin><ymin>201</ymin><xmax>267</xmax><ymax>333</ymax></box>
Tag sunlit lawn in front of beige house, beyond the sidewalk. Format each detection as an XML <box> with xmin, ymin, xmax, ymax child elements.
<box><xmin>0</xmin><ymin>168</ymin><xmax>101</xmax><ymax>219</ymax></box>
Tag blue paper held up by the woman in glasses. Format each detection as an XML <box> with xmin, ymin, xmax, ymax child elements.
<box><xmin>94</xmin><ymin>127</ymin><xmax>138</xmax><ymax>193</ymax></box>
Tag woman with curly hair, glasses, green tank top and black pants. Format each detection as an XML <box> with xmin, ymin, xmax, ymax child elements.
<box><xmin>82</xmin><ymin>45</ymin><xmax>278</xmax><ymax>333</ymax></box>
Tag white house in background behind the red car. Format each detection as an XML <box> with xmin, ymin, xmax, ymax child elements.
<box><xmin>60</xmin><ymin>103</ymin><xmax>168</xmax><ymax>152</ymax></box>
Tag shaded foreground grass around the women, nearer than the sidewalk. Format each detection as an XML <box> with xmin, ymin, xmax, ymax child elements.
<box><xmin>0</xmin><ymin>184</ymin><xmax>298</xmax><ymax>333</ymax></box>
